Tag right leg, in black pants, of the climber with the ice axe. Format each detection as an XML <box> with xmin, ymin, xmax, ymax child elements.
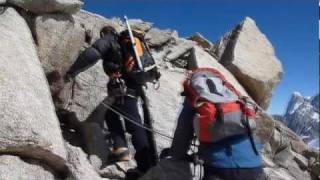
<box><xmin>123</xmin><ymin>97</ymin><xmax>152</xmax><ymax>173</ymax></box>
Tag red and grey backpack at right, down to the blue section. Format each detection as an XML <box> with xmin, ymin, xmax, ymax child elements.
<box><xmin>183</xmin><ymin>68</ymin><xmax>256</xmax><ymax>143</ymax></box>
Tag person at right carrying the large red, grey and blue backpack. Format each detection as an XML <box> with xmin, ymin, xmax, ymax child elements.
<box><xmin>170</xmin><ymin>68</ymin><xmax>262</xmax><ymax>180</ymax></box>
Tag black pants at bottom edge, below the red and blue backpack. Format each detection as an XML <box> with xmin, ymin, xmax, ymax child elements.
<box><xmin>202</xmin><ymin>167</ymin><xmax>264</xmax><ymax>180</ymax></box>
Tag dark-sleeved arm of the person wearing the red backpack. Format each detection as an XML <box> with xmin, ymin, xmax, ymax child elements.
<box><xmin>170</xmin><ymin>101</ymin><xmax>196</xmax><ymax>160</ymax></box>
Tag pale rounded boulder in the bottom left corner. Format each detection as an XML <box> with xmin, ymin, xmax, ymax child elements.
<box><xmin>0</xmin><ymin>155</ymin><xmax>57</xmax><ymax>180</ymax></box>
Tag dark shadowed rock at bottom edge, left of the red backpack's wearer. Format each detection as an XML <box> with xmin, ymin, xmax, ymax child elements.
<box><xmin>140</xmin><ymin>160</ymin><xmax>193</xmax><ymax>180</ymax></box>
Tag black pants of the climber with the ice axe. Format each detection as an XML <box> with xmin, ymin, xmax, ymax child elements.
<box><xmin>106</xmin><ymin>96</ymin><xmax>152</xmax><ymax>172</ymax></box>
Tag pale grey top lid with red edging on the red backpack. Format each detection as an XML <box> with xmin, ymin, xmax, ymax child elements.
<box><xmin>184</xmin><ymin>68</ymin><xmax>241</xmax><ymax>106</ymax></box>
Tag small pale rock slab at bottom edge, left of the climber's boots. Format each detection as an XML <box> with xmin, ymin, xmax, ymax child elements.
<box><xmin>66</xmin><ymin>143</ymin><xmax>101</xmax><ymax>180</ymax></box>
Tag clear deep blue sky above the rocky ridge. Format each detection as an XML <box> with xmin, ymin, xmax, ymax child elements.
<box><xmin>83</xmin><ymin>0</ymin><xmax>319</xmax><ymax>114</ymax></box>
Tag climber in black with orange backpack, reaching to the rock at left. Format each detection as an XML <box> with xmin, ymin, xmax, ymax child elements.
<box><xmin>66</xmin><ymin>26</ymin><xmax>160</xmax><ymax>179</ymax></box>
